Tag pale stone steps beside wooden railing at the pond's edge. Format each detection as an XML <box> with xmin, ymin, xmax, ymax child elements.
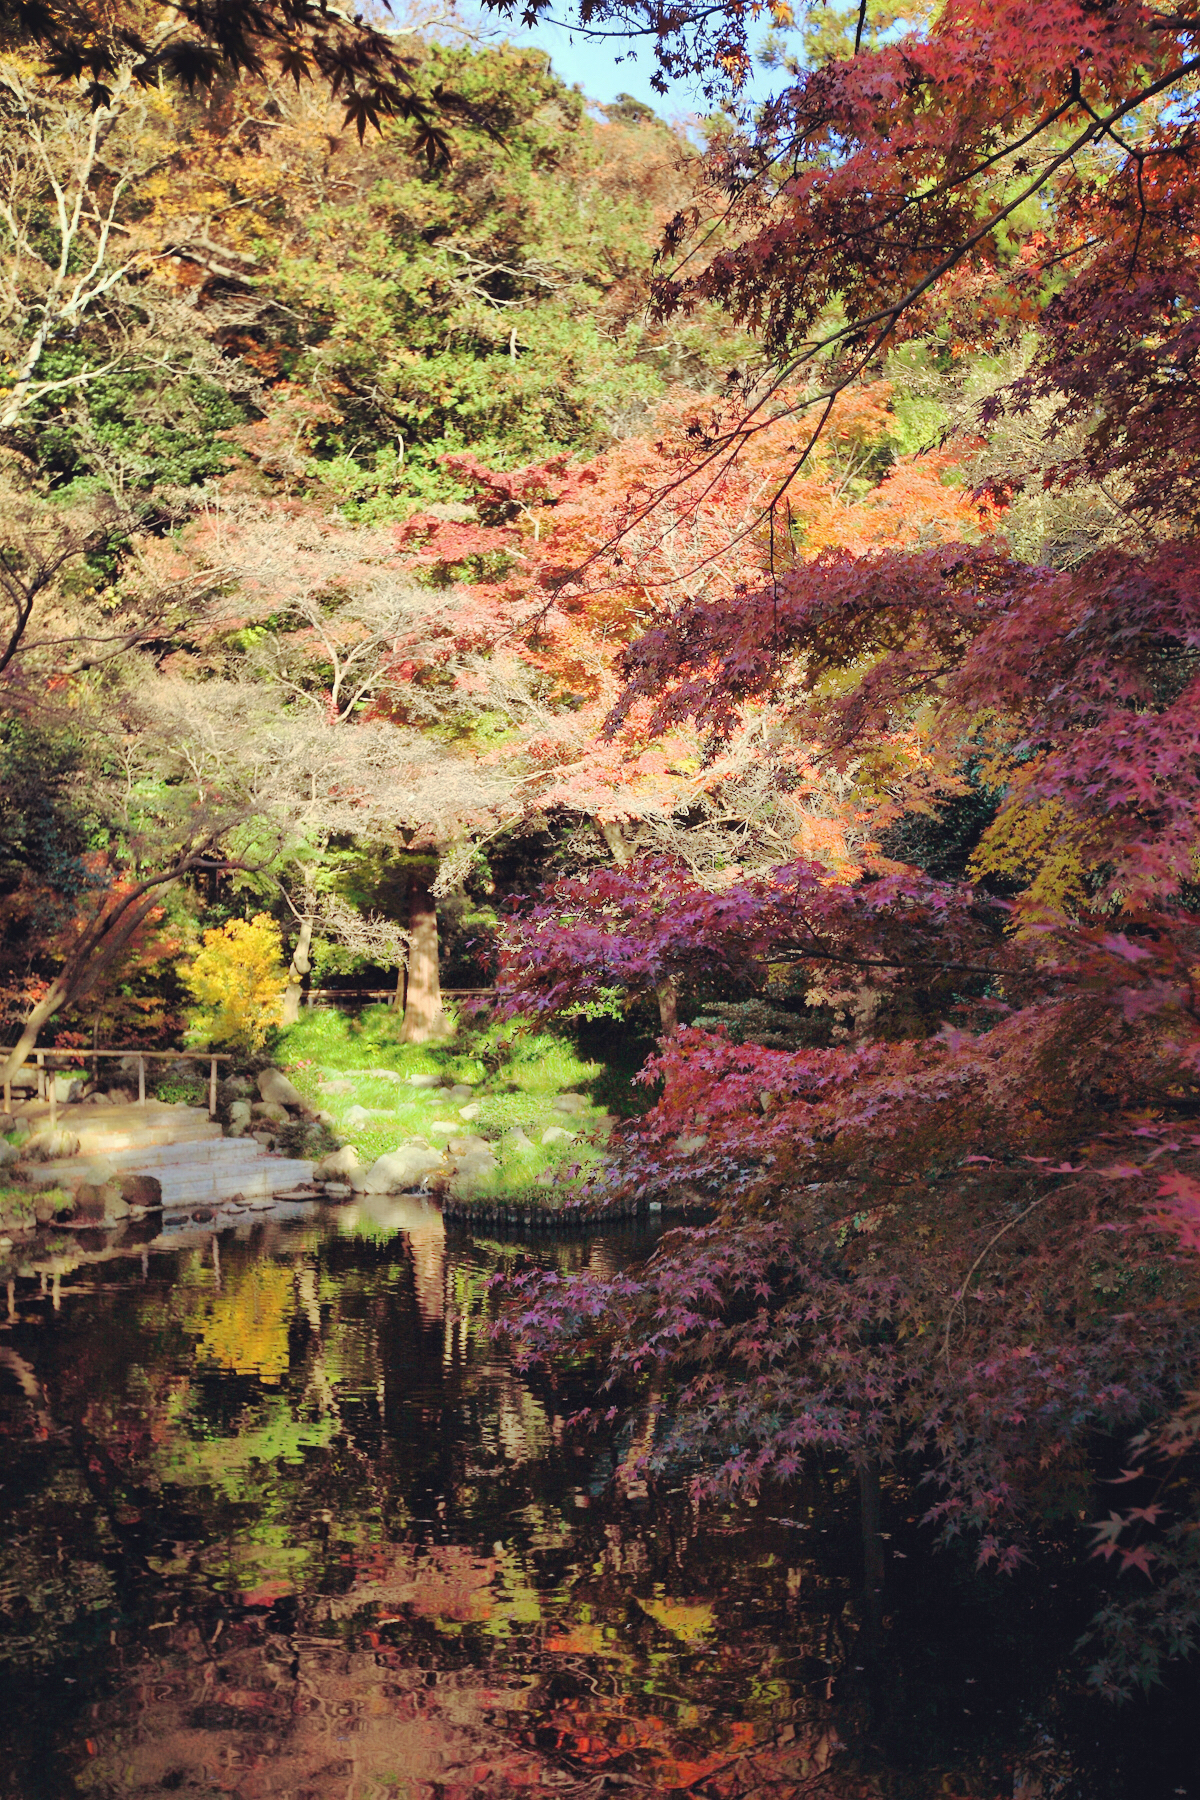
<box><xmin>31</xmin><ymin>1100</ymin><xmax>313</xmax><ymax>1210</ymax></box>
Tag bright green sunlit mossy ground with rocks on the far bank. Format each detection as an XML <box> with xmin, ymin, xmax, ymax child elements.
<box><xmin>273</xmin><ymin>1006</ymin><xmax>626</xmax><ymax>1206</ymax></box>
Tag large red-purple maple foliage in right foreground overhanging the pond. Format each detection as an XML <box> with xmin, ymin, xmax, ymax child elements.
<box><xmin>478</xmin><ymin>0</ymin><xmax>1200</xmax><ymax>1690</ymax></box>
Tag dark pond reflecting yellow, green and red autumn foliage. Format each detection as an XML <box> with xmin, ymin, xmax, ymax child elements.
<box><xmin>0</xmin><ymin>1199</ymin><xmax>1200</xmax><ymax>1800</ymax></box>
